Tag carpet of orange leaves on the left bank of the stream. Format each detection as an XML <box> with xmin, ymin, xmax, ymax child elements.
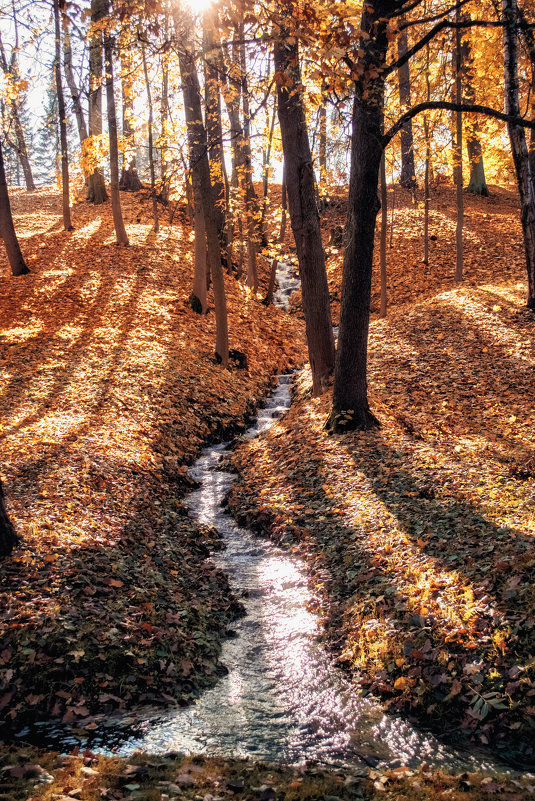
<box><xmin>0</xmin><ymin>189</ymin><xmax>304</xmax><ymax>725</ymax></box>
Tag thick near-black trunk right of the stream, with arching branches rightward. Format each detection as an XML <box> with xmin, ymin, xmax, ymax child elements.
<box><xmin>327</xmin><ymin>2</ymin><xmax>393</xmax><ymax>431</ymax></box>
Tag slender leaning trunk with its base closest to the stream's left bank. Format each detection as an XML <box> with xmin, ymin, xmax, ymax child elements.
<box><xmin>175</xmin><ymin>11</ymin><xmax>228</xmax><ymax>366</ymax></box>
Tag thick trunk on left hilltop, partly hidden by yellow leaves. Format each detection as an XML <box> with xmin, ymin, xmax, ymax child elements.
<box><xmin>87</xmin><ymin>0</ymin><xmax>108</xmax><ymax>205</ymax></box>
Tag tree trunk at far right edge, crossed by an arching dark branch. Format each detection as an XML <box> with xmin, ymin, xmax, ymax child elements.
<box><xmin>502</xmin><ymin>0</ymin><xmax>535</xmax><ymax>311</ymax></box>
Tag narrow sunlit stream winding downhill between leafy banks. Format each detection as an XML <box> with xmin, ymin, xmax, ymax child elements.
<box><xmin>23</xmin><ymin>266</ymin><xmax>504</xmax><ymax>771</ymax></box>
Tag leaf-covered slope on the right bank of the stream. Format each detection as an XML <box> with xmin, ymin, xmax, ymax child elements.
<box><xmin>230</xmin><ymin>184</ymin><xmax>535</xmax><ymax>763</ymax></box>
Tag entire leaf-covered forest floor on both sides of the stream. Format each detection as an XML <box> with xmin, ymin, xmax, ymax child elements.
<box><xmin>0</xmin><ymin>183</ymin><xmax>535</xmax><ymax>801</ymax></box>
